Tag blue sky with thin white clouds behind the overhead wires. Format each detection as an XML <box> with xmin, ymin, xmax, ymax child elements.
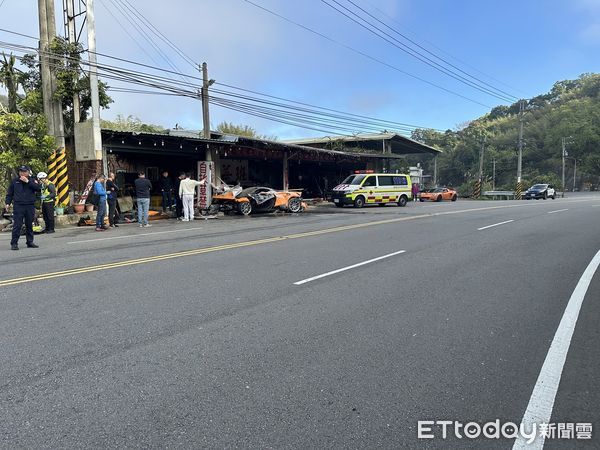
<box><xmin>0</xmin><ymin>0</ymin><xmax>600</xmax><ymax>138</ymax></box>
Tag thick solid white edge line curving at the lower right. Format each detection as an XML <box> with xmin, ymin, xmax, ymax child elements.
<box><xmin>513</xmin><ymin>250</ymin><xmax>600</xmax><ymax>450</ymax></box>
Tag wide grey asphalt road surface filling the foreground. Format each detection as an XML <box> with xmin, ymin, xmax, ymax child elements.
<box><xmin>0</xmin><ymin>194</ymin><xmax>600</xmax><ymax>448</ymax></box>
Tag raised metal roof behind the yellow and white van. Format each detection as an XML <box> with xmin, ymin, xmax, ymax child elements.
<box><xmin>283</xmin><ymin>132</ymin><xmax>442</xmax><ymax>155</ymax></box>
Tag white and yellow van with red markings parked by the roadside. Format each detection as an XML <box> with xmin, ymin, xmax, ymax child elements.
<box><xmin>331</xmin><ymin>170</ymin><xmax>412</xmax><ymax>208</ymax></box>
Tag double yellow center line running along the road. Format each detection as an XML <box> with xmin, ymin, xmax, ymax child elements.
<box><xmin>0</xmin><ymin>201</ymin><xmax>592</xmax><ymax>287</ymax></box>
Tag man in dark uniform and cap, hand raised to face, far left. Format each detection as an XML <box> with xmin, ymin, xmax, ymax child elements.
<box><xmin>5</xmin><ymin>166</ymin><xmax>42</xmax><ymax>250</ymax></box>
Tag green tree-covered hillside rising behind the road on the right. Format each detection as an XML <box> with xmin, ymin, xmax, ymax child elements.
<box><xmin>411</xmin><ymin>74</ymin><xmax>600</xmax><ymax>194</ymax></box>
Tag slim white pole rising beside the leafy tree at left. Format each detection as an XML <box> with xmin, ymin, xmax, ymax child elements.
<box><xmin>86</xmin><ymin>0</ymin><xmax>108</xmax><ymax>174</ymax></box>
